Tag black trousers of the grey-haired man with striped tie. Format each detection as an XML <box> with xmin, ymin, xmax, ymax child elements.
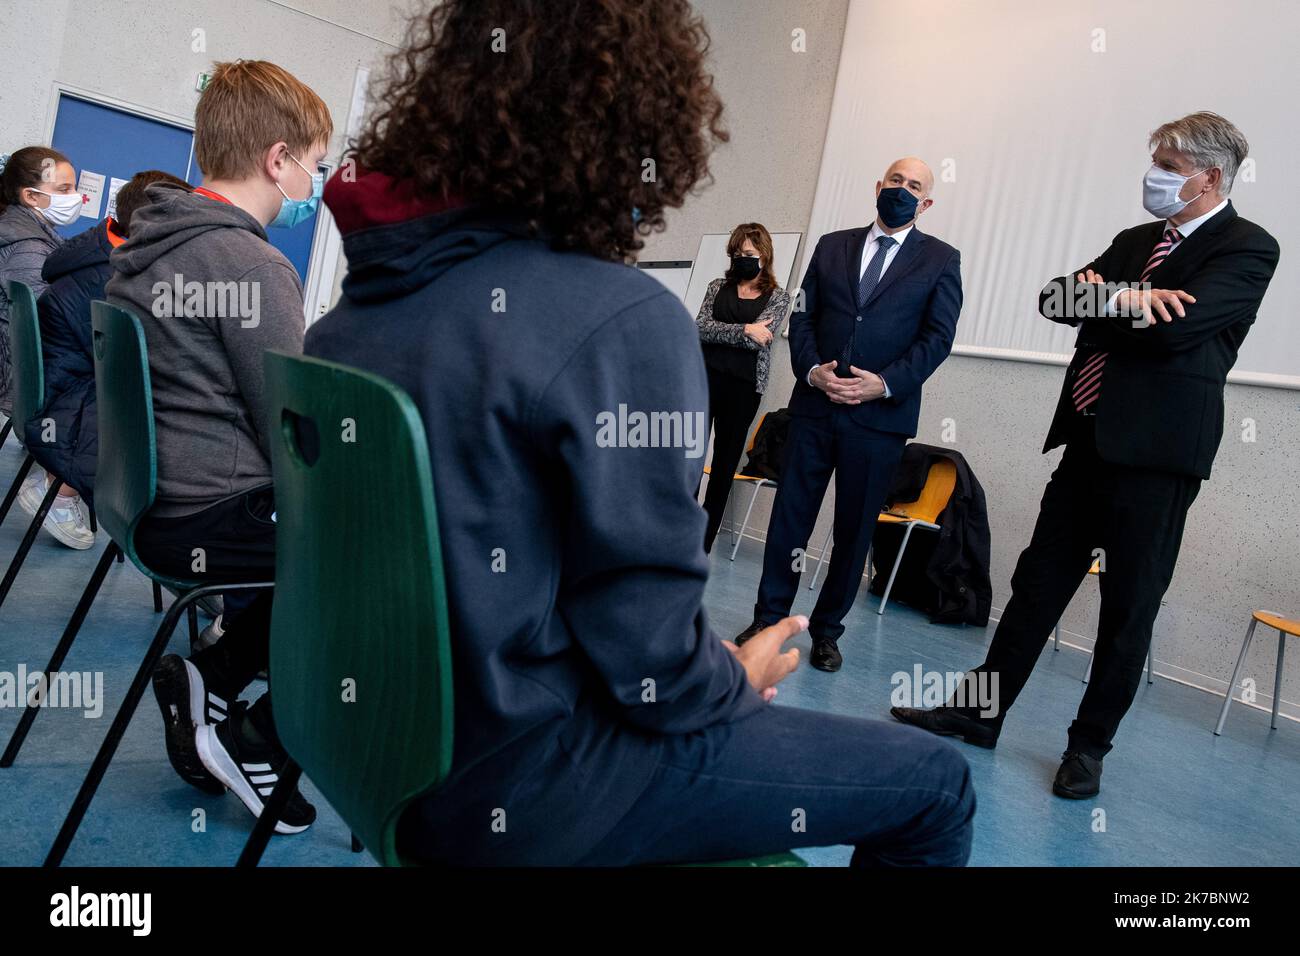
<box><xmin>967</xmin><ymin>416</ymin><xmax>1201</xmax><ymax>760</ymax></box>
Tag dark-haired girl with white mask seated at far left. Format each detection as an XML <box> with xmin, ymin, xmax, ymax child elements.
<box><xmin>0</xmin><ymin>146</ymin><xmax>85</xmax><ymax>418</ymax></box>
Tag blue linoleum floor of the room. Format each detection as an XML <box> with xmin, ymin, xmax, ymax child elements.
<box><xmin>0</xmin><ymin>440</ymin><xmax>1300</xmax><ymax>866</ymax></box>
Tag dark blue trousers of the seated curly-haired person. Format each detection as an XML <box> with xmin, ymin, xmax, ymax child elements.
<box><xmin>577</xmin><ymin>705</ymin><xmax>975</xmax><ymax>866</ymax></box>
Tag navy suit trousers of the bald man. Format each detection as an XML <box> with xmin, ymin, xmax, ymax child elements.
<box><xmin>754</xmin><ymin>408</ymin><xmax>906</xmax><ymax>640</ymax></box>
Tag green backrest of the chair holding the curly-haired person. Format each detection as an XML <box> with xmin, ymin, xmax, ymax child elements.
<box><xmin>264</xmin><ymin>351</ymin><xmax>452</xmax><ymax>865</ymax></box>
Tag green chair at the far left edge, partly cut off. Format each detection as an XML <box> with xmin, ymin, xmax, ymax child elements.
<box><xmin>0</xmin><ymin>280</ymin><xmax>66</xmax><ymax>605</ymax></box>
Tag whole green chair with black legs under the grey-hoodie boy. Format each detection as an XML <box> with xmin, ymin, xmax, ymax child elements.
<box><xmin>46</xmin><ymin>302</ymin><xmax>274</xmax><ymax>866</ymax></box>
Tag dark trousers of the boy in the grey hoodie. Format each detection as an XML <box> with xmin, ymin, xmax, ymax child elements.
<box><xmin>135</xmin><ymin>485</ymin><xmax>276</xmax><ymax>719</ymax></box>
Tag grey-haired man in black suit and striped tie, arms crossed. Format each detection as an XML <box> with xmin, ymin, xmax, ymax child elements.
<box><xmin>891</xmin><ymin>113</ymin><xmax>1278</xmax><ymax>799</ymax></box>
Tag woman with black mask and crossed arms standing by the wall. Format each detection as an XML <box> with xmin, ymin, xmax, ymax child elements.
<box><xmin>696</xmin><ymin>222</ymin><xmax>790</xmax><ymax>551</ymax></box>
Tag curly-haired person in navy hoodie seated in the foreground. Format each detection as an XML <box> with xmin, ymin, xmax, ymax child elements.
<box><xmin>306</xmin><ymin>0</ymin><xmax>975</xmax><ymax>865</ymax></box>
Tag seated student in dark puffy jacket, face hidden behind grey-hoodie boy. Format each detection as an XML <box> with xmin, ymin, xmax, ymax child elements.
<box><xmin>22</xmin><ymin>169</ymin><xmax>189</xmax><ymax>546</ymax></box>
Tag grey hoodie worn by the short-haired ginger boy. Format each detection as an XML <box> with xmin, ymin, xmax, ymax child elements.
<box><xmin>105</xmin><ymin>185</ymin><xmax>304</xmax><ymax>518</ymax></box>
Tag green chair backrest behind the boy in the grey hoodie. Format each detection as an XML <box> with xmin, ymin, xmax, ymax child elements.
<box><xmin>90</xmin><ymin>300</ymin><xmax>187</xmax><ymax>589</ymax></box>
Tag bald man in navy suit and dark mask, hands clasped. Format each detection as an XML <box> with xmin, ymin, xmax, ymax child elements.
<box><xmin>736</xmin><ymin>157</ymin><xmax>962</xmax><ymax>671</ymax></box>
